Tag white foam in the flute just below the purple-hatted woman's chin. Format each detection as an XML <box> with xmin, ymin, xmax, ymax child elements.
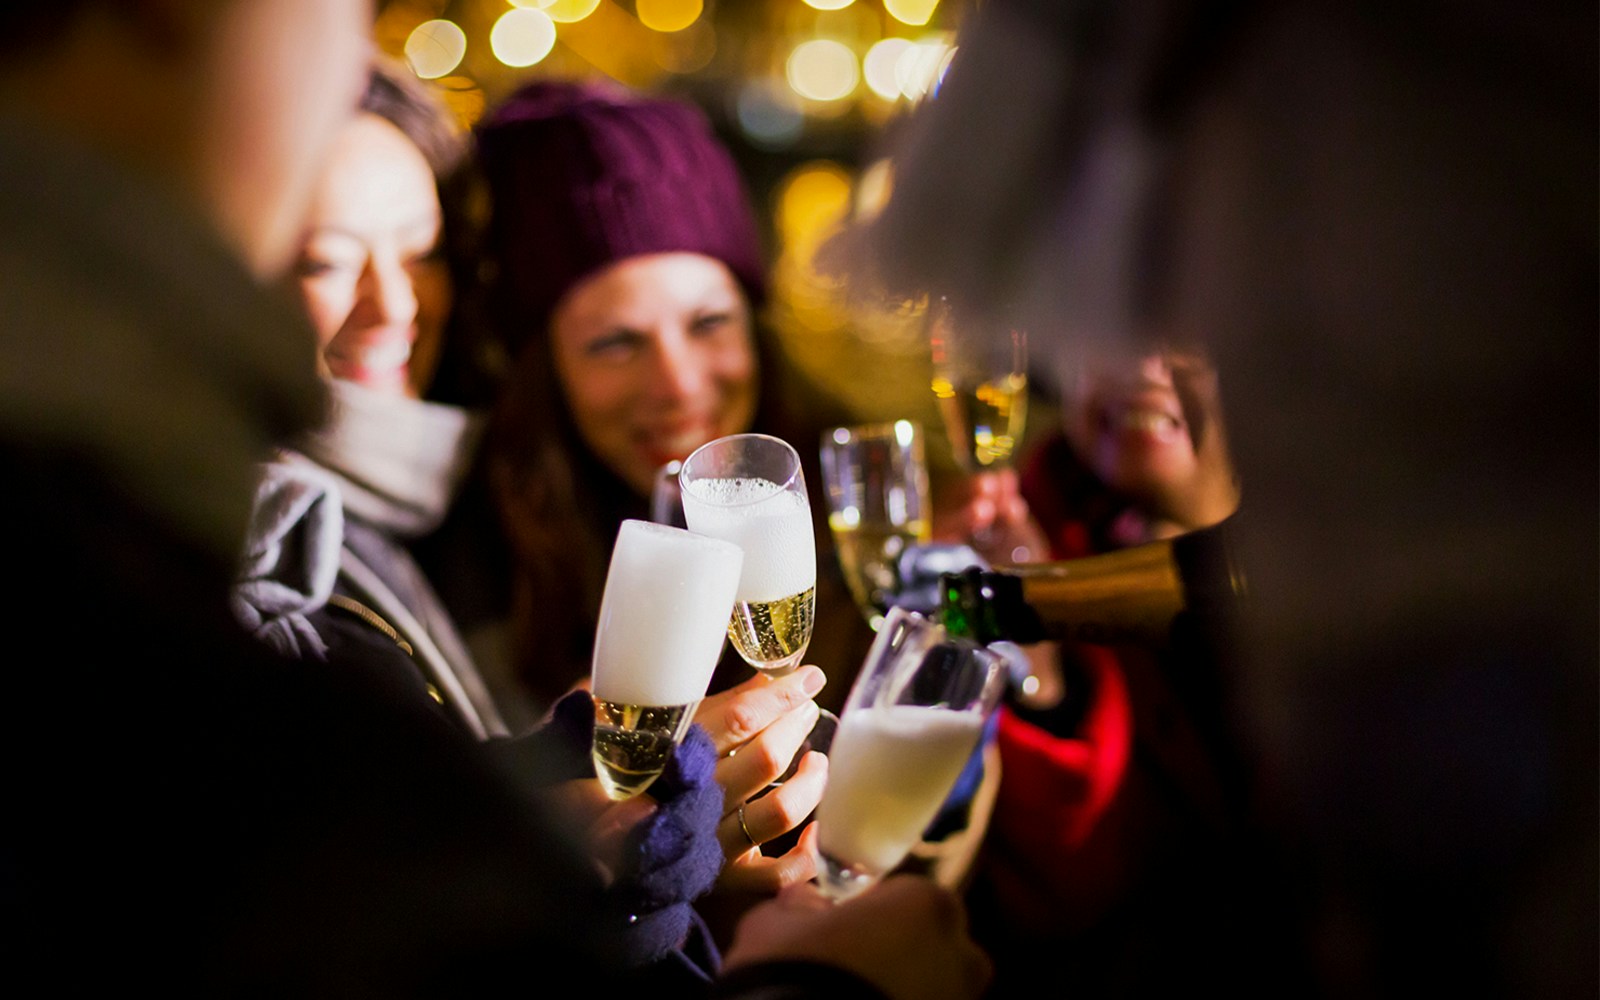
<box><xmin>683</xmin><ymin>478</ymin><xmax>816</xmax><ymax>602</ymax></box>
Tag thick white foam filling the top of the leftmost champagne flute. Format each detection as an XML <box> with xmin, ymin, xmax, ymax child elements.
<box><xmin>594</xmin><ymin>520</ymin><xmax>744</xmax><ymax>706</ymax></box>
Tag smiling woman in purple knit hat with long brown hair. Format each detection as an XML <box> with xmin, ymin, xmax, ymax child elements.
<box><xmin>429</xmin><ymin>80</ymin><xmax>866</xmax><ymax>890</ymax></box>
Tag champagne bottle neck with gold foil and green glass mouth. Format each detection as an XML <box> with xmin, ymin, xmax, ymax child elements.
<box><xmin>941</xmin><ymin>518</ymin><xmax>1245</xmax><ymax>648</ymax></box>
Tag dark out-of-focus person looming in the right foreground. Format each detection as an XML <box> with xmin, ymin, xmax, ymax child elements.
<box><xmin>872</xmin><ymin>0</ymin><xmax>1600</xmax><ymax>994</ymax></box>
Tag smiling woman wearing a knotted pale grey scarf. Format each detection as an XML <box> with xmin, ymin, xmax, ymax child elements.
<box><xmin>225</xmin><ymin>58</ymin><xmax>506</xmax><ymax>738</ymax></box>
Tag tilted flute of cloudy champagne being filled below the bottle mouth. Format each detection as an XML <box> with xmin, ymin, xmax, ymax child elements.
<box><xmin>816</xmin><ymin>608</ymin><xmax>1005</xmax><ymax>899</ymax></box>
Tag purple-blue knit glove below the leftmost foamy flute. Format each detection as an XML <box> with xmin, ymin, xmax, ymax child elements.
<box><xmin>610</xmin><ymin>725</ymin><xmax>723</xmax><ymax>965</ymax></box>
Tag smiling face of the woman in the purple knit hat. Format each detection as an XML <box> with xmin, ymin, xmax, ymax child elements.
<box><xmin>550</xmin><ymin>253</ymin><xmax>755</xmax><ymax>496</ymax></box>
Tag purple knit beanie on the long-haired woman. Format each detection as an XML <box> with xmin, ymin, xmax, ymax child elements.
<box><xmin>477</xmin><ymin>80</ymin><xmax>765</xmax><ymax>352</ymax></box>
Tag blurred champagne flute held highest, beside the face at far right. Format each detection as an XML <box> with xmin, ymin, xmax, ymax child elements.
<box><xmin>928</xmin><ymin>296</ymin><xmax>1027</xmax><ymax>474</ymax></box>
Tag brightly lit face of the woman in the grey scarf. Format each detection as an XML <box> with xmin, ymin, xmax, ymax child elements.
<box><xmin>296</xmin><ymin>114</ymin><xmax>451</xmax><ymax>397</ymax></box>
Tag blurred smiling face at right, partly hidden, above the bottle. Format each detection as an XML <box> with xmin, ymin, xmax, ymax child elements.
<box><xmin>1064</xmin><ymin>352</ymin><xmax>1237</xmax><ymax>526</ymax></box>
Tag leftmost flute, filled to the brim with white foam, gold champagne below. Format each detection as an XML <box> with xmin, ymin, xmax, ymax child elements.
<box><xmin>592</xmin><ymin>520</ymin><xmax>744</xmax><ymax>800</ymax></box>
